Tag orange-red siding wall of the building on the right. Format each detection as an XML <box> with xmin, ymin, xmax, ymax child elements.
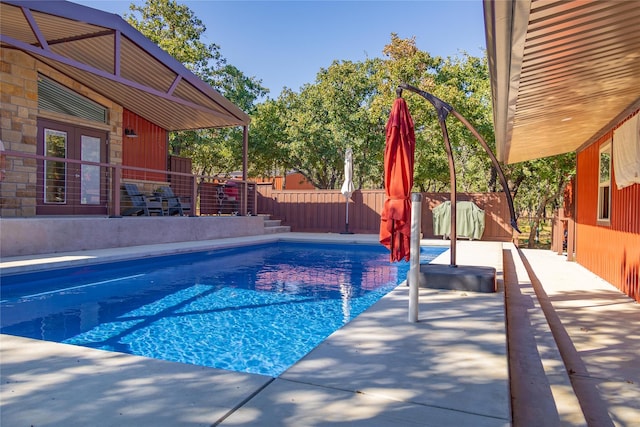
<box><xmin>576</xmin><ymin>112</ymin><xmax>640</xmax><ymax>302</ymax></box>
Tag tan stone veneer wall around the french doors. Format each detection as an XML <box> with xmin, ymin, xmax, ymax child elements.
<box><xmin>0</xmin><ymin>48</ymin><xmax>122</xmax><ymax>217</ymax></box>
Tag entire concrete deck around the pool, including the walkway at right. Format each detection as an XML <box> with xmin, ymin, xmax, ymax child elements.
<box><xmin>0</xmin><ymin>233</ymin><xmax>640</xmax><ymax>426</ymax></box>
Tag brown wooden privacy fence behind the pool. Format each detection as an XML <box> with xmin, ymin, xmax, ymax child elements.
<box><xmin>257</xmin><ymin>184</ymin><xmax>512</xmax><ymax>242</ymax></box>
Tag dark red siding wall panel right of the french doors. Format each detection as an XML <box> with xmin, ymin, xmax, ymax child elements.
<box><xmin>122</xmin><ymin>110</ymin><xmax>169</xmax><ymax>181</ymax></box>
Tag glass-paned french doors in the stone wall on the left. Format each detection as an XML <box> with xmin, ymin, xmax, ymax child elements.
<box><xmin>36</xmin><ymin>119</ymin><xmax>107</xmax><ymax>215</ymax></box>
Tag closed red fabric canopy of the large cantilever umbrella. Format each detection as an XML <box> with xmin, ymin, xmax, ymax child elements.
<box><xmin>380</xmin><ymin>98</ymin><xmax>416</xmax><ymax>261</ymax></box>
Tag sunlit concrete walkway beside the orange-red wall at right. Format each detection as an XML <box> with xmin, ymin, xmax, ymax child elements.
<box><xmin>522</xmin><ymin>249</ymin><xmax>640</xmax><ymax>427</ymax></box>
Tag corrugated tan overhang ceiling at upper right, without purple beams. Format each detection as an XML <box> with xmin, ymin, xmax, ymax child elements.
<box><xmin>484</xmin><ymin>0</ymin><xmax>640</xmax><ymax>163</ymax></box>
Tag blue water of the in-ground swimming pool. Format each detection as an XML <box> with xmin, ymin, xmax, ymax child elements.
<box><xmin>0</xmin><ymin>242</ymin><xmax>446</xmax><ymax>376</ymax></box>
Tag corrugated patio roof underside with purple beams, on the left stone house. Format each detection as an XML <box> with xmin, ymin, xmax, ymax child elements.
<box><xmin>0</xmin><ymin>0</ymin><xmax>250</xmax><ymax>131</ymax></box>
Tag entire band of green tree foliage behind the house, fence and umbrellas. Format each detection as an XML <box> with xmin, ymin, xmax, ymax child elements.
<box><xmin>126</xmin><ymin>0</ymin><xmax>575</xmax><ymax>222</ymax></box>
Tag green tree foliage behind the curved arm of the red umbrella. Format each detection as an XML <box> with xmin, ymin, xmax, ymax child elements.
<box><xmin>376</xmin><ymin>34</ymin><xmax>494</xmax><ymax>191</ymax></box>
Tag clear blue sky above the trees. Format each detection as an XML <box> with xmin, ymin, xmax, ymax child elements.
<box><xmin>75</xmin><ymin>0</ymin><xmax>486</xmax><ymax>98</ymax></box>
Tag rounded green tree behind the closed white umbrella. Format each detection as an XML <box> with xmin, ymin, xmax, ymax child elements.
<box><xmin>270</xmin><ymin>60</ymin><xmax>384</xmax><ymax>189</ymax></box>
